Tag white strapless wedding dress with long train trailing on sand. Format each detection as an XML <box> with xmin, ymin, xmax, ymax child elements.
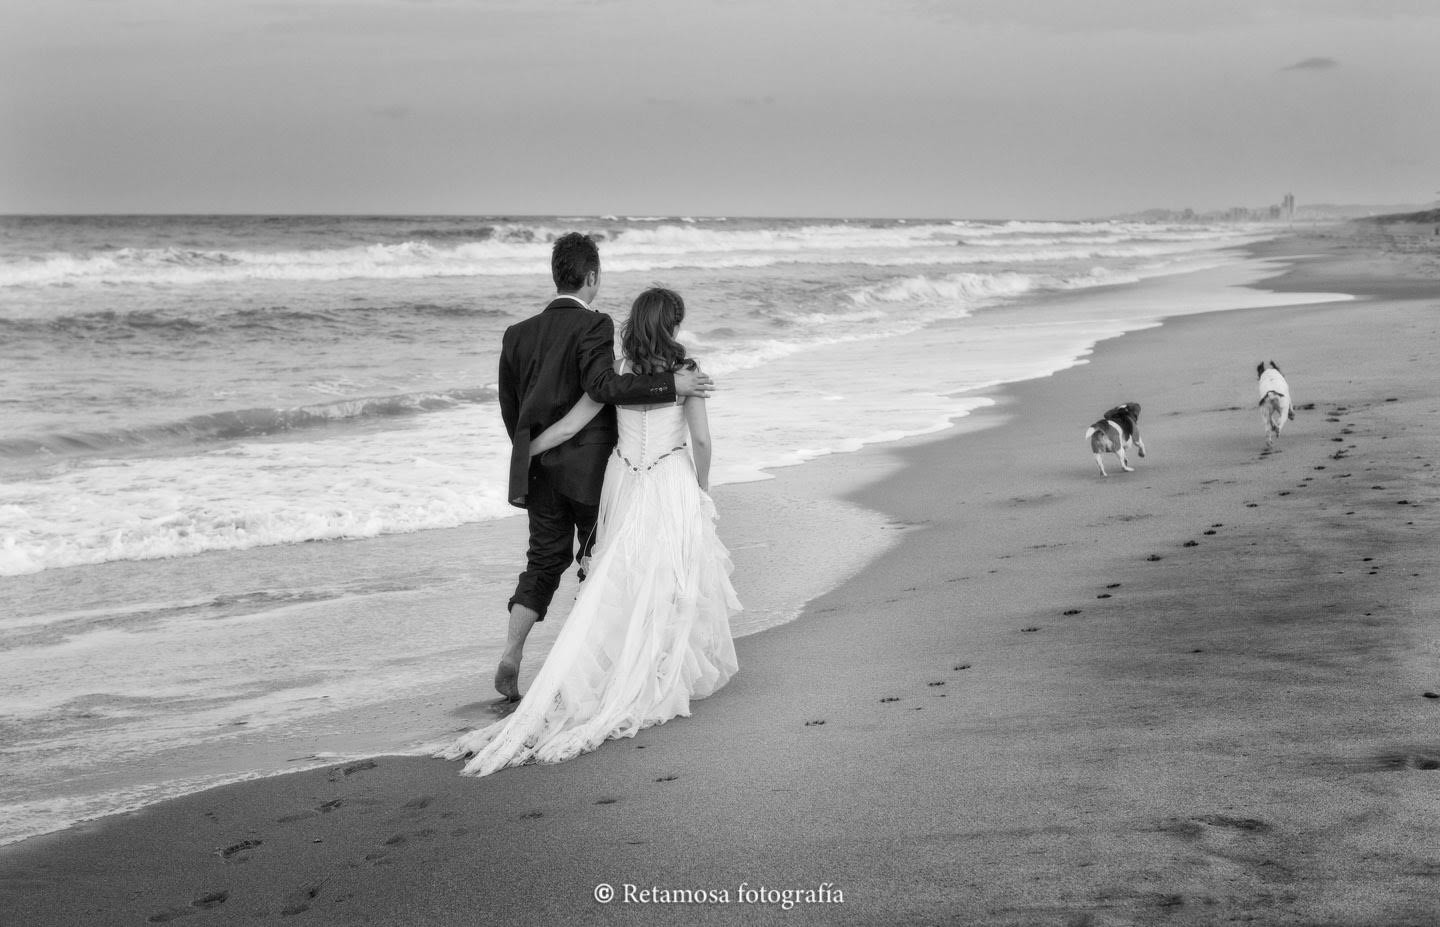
<box><xmin>439</xmin><ymin>406</ymin><xmax>740</xmax><ymax>776</ymax></box>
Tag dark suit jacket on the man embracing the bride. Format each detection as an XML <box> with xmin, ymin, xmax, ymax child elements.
<box><xmin>500</xmin><ymin>297</ymin><xmax>675</xmax><ymax>508</ymax></box>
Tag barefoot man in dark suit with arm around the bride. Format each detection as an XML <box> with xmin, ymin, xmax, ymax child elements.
<box><xmin>495</xmin><ymin>232</ymin><xmax>714</xmax><ymax>701</ymax></box>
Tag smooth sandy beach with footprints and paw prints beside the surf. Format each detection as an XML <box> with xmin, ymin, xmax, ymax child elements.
<box><xmin>0</xmin><ymin>227</ymin><xmax>1440</xmax><ymax>927</ymax></box>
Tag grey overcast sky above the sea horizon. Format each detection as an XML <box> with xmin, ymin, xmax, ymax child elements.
<box><xmin>0</xmin><ymin>0</ymin><xmax>1440</xmax><ymax>219</ymax></box>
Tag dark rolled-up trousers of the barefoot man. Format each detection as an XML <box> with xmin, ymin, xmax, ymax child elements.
<box><xmin>505</xmin><ymin>466</ymin><xmax>600</xmax><ymax>620</ymax></box>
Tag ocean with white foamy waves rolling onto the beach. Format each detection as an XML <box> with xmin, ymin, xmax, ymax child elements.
<box><xmin>0</xmin><ymin>216</ymin><xmax>1347</xmax><ymax>842</ymax></box>
